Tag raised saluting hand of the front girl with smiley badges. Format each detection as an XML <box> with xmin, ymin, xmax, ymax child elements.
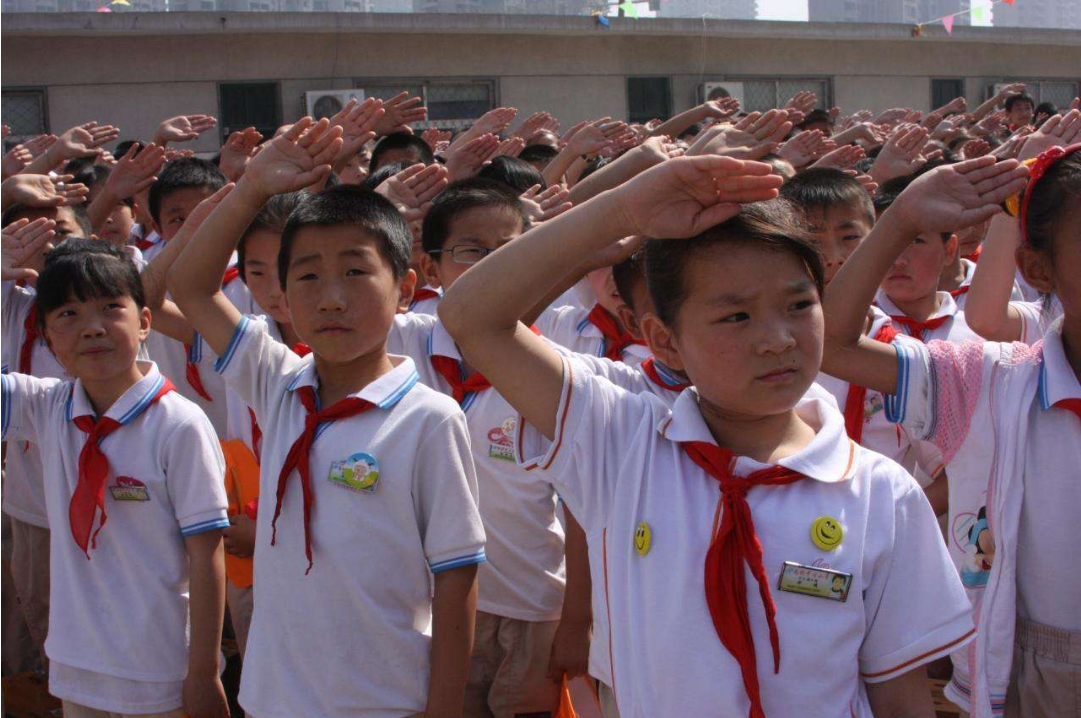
<box><xmin>613</xmin><ymin>156</ymin><xmax>784</xmax><ymax>239</ymax></box>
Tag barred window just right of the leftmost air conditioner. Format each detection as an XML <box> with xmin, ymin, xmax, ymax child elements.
<box><xmin>357</xmin><ymin>80</ymin><xmax>495</xmax><ymax>130</ymax></box>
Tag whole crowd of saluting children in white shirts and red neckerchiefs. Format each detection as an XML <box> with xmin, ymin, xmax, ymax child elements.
<box><xmin>2</xmin><ymin>80</ymin><xmax>1081</xmax><ymax>718</ymax></box>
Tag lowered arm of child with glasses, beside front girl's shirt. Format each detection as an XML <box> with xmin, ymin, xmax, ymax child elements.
<box><xmin>548</xmin><ymin>504</ymin><xmax>592</xmax><ymax>682</ymax></box>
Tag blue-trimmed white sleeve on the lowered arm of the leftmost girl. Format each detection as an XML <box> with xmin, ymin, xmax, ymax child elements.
<box><xmin>163</xmin><ymin>407</ymin><xmax>229</xmax><ymax>537</ymax></box>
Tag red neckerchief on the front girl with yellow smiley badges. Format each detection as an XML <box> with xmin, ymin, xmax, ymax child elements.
<box><xmin>680</xmin><ymin>441</ymin><xmax>806</xmax><ymax>718</ymax></box>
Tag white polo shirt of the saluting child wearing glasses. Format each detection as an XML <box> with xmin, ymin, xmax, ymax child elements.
<box><xmin>387</xmin><ymin>314</ymin><xmax>566</xmax><ymax>621</ymax></box>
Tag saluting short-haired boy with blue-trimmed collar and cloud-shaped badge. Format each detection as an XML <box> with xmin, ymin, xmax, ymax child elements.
<box><xmin>170</xmin><ymin>118</ymin><xmax>484</xmax><ymax>718</ymax></box>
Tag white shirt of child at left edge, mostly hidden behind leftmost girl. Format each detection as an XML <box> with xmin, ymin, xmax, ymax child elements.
<box><xmin>2</xmin><ymin>282</ymin><xmax>71</xmax><ymax>529</ymax></box>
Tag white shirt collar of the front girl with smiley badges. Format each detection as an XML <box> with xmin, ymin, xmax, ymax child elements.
<box><xmin>657</xmin><ymin>388</ymin><xmax>856</xmax><ymax>483</ymax></box>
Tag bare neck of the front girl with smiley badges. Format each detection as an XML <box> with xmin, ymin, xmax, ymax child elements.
<box><xmin>698</xmin><ymin>396</ymin><xmax>815</xmax><ymax>464</ymax></box>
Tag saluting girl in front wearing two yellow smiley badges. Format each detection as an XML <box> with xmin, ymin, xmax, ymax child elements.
<box><xmin>440</xmin><ymin>157</ymin><xmax>972</xmax><ymax>718</ymax></box>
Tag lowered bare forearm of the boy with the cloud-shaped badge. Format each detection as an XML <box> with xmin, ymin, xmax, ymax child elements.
<box><xmin>424</xmin><ymin>563</ymin><xmax>477</xmax><ymax>718</ymax></box>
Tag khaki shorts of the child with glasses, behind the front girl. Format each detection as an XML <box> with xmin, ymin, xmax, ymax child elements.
<box><xmin>463</xmin><ymin>611</ymin><xmax>560</xmax><ymax>718</ymax></box>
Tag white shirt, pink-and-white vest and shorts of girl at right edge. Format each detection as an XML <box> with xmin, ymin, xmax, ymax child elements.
<box><xmin>886</xmin><ymin>319</ymin><xmax>1081</xmax><ymax>718</ymax></box>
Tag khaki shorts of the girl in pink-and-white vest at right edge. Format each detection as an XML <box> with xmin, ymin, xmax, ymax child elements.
<box><xmin>1005</xmin><ymin>618</ymin><xmax>1081</xmax><ymax>718</ymax></box>
